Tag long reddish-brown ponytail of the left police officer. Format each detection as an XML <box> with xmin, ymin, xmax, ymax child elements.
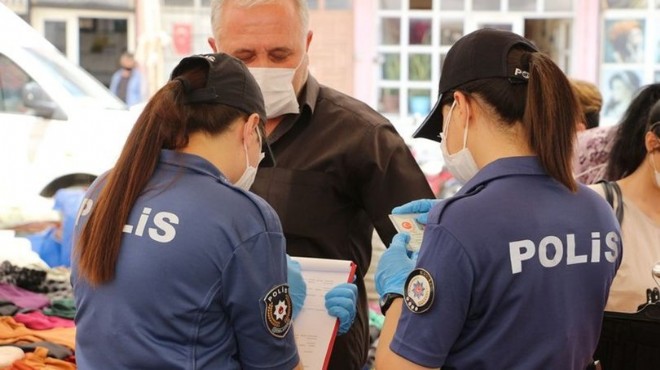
<box><xmin>74</xmin><ymin>68</ymin><xmax>247</xmax><ymax>286</ymax></box>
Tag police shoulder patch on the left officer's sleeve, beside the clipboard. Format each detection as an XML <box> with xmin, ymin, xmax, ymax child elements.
<box><xmin>264</xmin><ymin>284</ymin><xmax>293</xmax><ymax>338</ymax></box>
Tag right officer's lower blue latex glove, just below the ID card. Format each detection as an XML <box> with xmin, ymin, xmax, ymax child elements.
<box><xmin>374</xmin><ymin>233</ymin><xmax>417</xmax><ymax>297</ymax></box>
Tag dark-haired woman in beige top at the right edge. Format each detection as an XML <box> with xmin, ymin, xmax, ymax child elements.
<box><xmin>590</xmin><ymin>84</ymin><xmax>660</xmax><ymax>313</ymax></box>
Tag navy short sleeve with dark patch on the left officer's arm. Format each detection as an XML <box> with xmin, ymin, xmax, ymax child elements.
<box><xmin>222</xmin><ymin>232</ymin><xmax>299</xmax><ymax>369</ymax></box>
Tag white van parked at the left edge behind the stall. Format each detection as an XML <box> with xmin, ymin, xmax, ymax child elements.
<box><xmin>0</xmin><ymin>3</ymin><xmax>139</xmax><ymax>229</ymax></box>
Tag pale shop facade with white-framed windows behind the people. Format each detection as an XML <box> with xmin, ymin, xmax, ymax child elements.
<box><xmin>10</xmin><ymin>0</ymin><xmax>660</xmax><ymax>128</ymax></box>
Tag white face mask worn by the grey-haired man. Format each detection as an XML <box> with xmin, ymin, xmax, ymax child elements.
<box><xmin>248</xmin><ymin>57</ymin><xmax>304</xmax><ymax>119</ymax></box>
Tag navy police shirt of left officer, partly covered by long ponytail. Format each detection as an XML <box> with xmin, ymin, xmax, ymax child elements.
<box><xmin>72</xmin><ymin>150</ymin><xmax>299</xmax><ymax>369</ymax></box>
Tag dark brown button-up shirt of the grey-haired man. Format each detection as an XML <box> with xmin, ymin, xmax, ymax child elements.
<box><xmin>252</xmin><ymin>76</ymin><xmax>434</xmax><ymax>370</ymax></box>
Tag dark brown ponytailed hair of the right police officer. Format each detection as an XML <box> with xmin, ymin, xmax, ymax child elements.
<box><xmin>442</xmin><ymin>47</ymin><xmax>582</xmax><ymax>192</ymax></box>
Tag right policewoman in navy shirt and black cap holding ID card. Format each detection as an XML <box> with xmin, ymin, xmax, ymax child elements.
<box><xmin>375</xmin><ymin>29</ymin><xmax>622</xmax><ymax>370</ymax></box>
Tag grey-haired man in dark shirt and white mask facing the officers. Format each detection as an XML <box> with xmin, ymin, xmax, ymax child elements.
<box><xmin>208</xmin><ymin>0</ymin><xmax>433</xmax><ymax>370</ymax></box>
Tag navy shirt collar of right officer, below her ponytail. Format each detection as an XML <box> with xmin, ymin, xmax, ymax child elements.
<box><xmin>456</xmin><ymin>156</ymin><xmax>548</xmax><ymax>195</ymax></box>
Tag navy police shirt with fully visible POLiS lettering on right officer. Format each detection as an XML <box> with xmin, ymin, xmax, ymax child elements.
<box><xmin>390</xmin><ymin>157</ymin><xmax>622</xmax><ymax>370</ymax></box>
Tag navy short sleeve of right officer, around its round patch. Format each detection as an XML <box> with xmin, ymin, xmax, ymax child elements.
<box><xmin>390</xmin><ymin>224</ymin><xmax>475</xmax><ymax>368</ymax></box>
